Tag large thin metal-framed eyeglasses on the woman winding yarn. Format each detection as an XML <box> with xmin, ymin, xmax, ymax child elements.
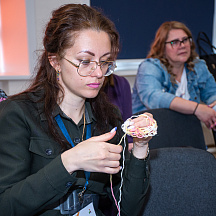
<box><xmin>63</xmin><ymin>57</ymin><xmax>117</xmax><ymax>77</ymax></box>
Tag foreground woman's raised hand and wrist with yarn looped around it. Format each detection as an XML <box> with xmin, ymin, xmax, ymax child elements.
<box><xmin>131</xmin><ymin>113</ymin><xmax>153</xmax><ymax>159</ymax></box>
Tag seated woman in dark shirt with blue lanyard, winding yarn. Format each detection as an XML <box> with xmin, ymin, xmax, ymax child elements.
<box><xmin>0</xmin><ymin>4</ymin><xmax>152</xmax><ymax>216</ymax></box>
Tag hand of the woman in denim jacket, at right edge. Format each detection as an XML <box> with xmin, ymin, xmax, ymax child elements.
<box><xmin>195</xmin><ymin>104</ymin><xmax>216</xmax><ymax>129</ymax></box>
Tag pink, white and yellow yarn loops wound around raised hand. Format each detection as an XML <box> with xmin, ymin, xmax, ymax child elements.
<box><xmin>121</xmin><ymin>114</ymin><xmax>158</xmax><ymax>138</ymax></box>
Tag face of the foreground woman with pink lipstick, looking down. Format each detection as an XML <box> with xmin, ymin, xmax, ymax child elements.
<box><xmin>59</xmin><ymin>30</ymin><xmax>111</xmax><ymax>99</ymax></box>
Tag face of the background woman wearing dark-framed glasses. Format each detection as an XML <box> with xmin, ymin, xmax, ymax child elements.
<box><xmin>165</xmin><ymin>29</ymin><xmax>191</xmax><ymax>66</ymax></box>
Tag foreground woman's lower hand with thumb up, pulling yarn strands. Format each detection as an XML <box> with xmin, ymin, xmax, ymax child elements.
<box><xmin>61</xmin><ymin>128</ymin><xmax>122</xmax><ymax>174</ymax></box>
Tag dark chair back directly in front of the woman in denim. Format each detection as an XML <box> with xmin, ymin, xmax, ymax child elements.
<box><xmin>137</xmin><ymin>108</ymin><xmax>206</xmax><ymax>150</ymax></box>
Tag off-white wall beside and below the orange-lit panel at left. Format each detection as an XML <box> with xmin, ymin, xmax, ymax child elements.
<box><xmin>0</xmin><ymin>0</ymin><xmax>90</xmax><ymax>95</ymax></box>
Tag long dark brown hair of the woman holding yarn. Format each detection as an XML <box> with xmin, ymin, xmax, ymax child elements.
<box><xmin>13</xmin><ymin>4</ymin><xmax>119</xmax><ymax>150</ymax></box>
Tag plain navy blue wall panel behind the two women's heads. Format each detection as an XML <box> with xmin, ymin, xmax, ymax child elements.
<box><xmin>91</xmin><ymin>0</ymin><xmax>214</xmax><ymax>59</ymax></box>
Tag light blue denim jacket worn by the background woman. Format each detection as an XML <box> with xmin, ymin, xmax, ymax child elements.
<box><xmin>132</xmin><ymin>58</ymin><xmax>216</xmax><ymax>113</ymax></box>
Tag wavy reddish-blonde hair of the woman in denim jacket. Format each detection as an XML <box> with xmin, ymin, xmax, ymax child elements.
<box><xmin>147</xmin><ymin>21</ymin><xmax>198</xmax><ymax>80</ymax></box>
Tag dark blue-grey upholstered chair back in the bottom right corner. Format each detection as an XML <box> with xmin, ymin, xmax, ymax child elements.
<box><xmin>140</xmin><ymin>147</ymin><xmax>216</xmax><ymax>216</ymax></box>
